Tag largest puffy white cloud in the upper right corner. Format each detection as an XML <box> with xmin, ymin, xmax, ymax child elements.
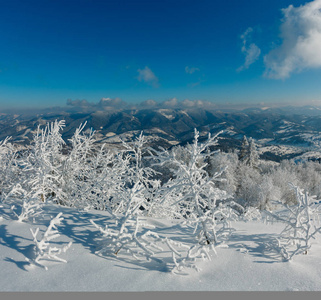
<box><xmin>264</xmin><ymin>0</ymin><xmax>321</xmax><ymax>79</ymax></box>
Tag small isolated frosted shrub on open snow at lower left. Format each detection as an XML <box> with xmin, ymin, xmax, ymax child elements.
<box><xmin>26</xmin><ymin>213</ymin><xmax>72</xmax><ymax>270</ymax></box>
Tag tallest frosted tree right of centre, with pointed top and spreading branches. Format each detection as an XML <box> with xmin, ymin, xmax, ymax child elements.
<box><xmin>152</xmin><ymin>129</ymin><xmax>238</xmax><ymax>251</ymax></box>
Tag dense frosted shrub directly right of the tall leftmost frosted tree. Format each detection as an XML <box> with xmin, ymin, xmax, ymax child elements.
<box><xmin>59</xmin><ymin>123</ymin><xmax>122</xmax><ymax>210</ymax></box>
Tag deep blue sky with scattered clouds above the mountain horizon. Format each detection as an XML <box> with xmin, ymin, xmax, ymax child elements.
<box><xmin>0</xmin><ymin>0</ymin><xmax>321</xmax><ymax>108</ymax></box>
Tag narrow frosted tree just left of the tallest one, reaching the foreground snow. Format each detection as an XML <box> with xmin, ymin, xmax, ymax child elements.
<box><xmin>92</xmin><ymin>133</ymin><xmax>159</xmax><ymax>258</ymax></box>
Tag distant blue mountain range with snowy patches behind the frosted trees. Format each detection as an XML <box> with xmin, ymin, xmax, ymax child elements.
<box><xmin>0</xmin><ymin>106</ymin><xmax>321</xmax><ymax>160</ymax></box>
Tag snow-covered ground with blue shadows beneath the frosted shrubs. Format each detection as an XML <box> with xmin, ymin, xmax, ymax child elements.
<box><xmin>0</xmin><ymin>203</ymin><xmax>321</xmax><ymax>292</ymax></box>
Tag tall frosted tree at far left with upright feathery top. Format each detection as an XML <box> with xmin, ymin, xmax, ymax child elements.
<box><xmin>4</xmin><ymin>121</ymin><xmax>64</xmax><ymax>222</ymax></box>
